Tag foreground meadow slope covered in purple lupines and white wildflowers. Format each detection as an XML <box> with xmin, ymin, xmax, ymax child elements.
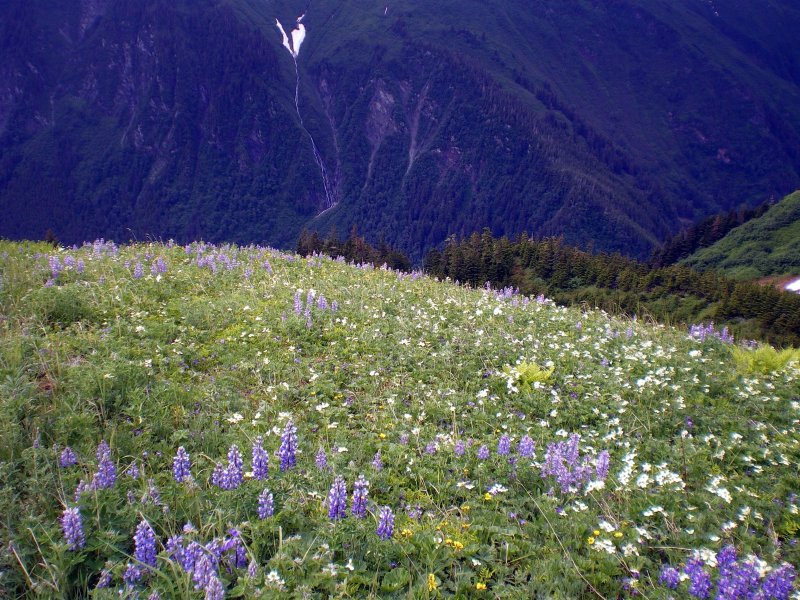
<box><xmin>0</xmin><ymin>242</ymin><xmax>800</xmax><ymax>599</ymax></box>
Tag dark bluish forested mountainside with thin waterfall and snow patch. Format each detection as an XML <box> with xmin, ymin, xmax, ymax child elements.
<box><xmin>0</xmin><ymin>0</ymin><xmax>800</xmax><ymax>260</ymax></box>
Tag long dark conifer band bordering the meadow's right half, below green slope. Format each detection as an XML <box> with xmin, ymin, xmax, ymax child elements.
<box><xmin>425</xmin><ymin>231</ymin><xmax>800</xmax><ymax>345</ymax></box>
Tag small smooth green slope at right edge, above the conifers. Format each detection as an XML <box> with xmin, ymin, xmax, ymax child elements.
<box><xmin>681</xmin><ymin>192</ymin><xmax>800</xmax><ymax>279</ymax></box>
